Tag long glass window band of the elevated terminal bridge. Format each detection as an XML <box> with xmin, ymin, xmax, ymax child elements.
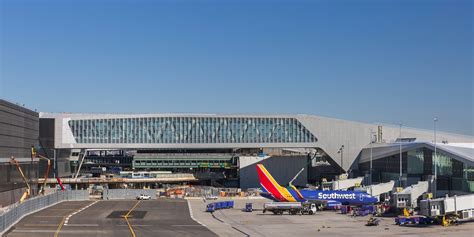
<box><xmin>69</xmin><ymin>117</ymin><xmax>317</xmax><ymax>144</ymax></box>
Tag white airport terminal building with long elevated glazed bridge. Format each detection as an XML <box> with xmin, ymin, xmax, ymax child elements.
<box><xmin>39</xmin><ymin>113</ymin><xmax>474</xmax><ymax>195</ymax></box>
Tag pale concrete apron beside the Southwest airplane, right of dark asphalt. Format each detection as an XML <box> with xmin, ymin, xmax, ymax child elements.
<box><xmin>189</xmin><ymin>199</ymin><xmax>474</xmax><ymax>237</ymax></box>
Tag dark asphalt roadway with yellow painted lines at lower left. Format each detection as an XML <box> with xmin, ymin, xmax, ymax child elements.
<box><xmin>6</xmin><ymin>199</ymin><xmax>216</xmax><ymax>237</ymax></box>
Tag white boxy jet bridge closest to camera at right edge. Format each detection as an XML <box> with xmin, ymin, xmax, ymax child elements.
<box><xmin>420</xmin><ymin>194</ymin><xmax>474</xmax><ymax>221</ymax></box>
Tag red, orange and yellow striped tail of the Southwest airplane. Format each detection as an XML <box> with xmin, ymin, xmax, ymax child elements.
<box><xmin>257</xmin><ymin>164</ymin><xmax>296</xmax><ymax>202</ymax></box>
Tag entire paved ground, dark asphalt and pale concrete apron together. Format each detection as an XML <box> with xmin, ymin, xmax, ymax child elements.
<box><xmin>6</xmin><ymin>199</ymin><xmax>474</xmax><ymax>237</ymax></box>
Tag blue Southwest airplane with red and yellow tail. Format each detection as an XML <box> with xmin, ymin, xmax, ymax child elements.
<box><xmin>257</xmin><ymin>164</ymin><xmax>377</xmax><ymax>207</ymax></box>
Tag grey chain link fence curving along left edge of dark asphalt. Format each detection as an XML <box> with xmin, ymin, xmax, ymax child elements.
<box><xmin>0</xmin><ymin>190</ymin><xmax>89</xmax><ymax>236</ymax></box>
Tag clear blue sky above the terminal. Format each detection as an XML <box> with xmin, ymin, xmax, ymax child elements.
<box><xmin>0</xmin><ymin>0</ymin><xmax>474</xmax><ymax>135</ymax></box>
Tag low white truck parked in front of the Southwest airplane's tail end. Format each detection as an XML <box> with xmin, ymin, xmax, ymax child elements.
<box><xmin>263</xmin><ymin>202</ymin><xmax>316</xmax><ymax>215</ymax></box>
